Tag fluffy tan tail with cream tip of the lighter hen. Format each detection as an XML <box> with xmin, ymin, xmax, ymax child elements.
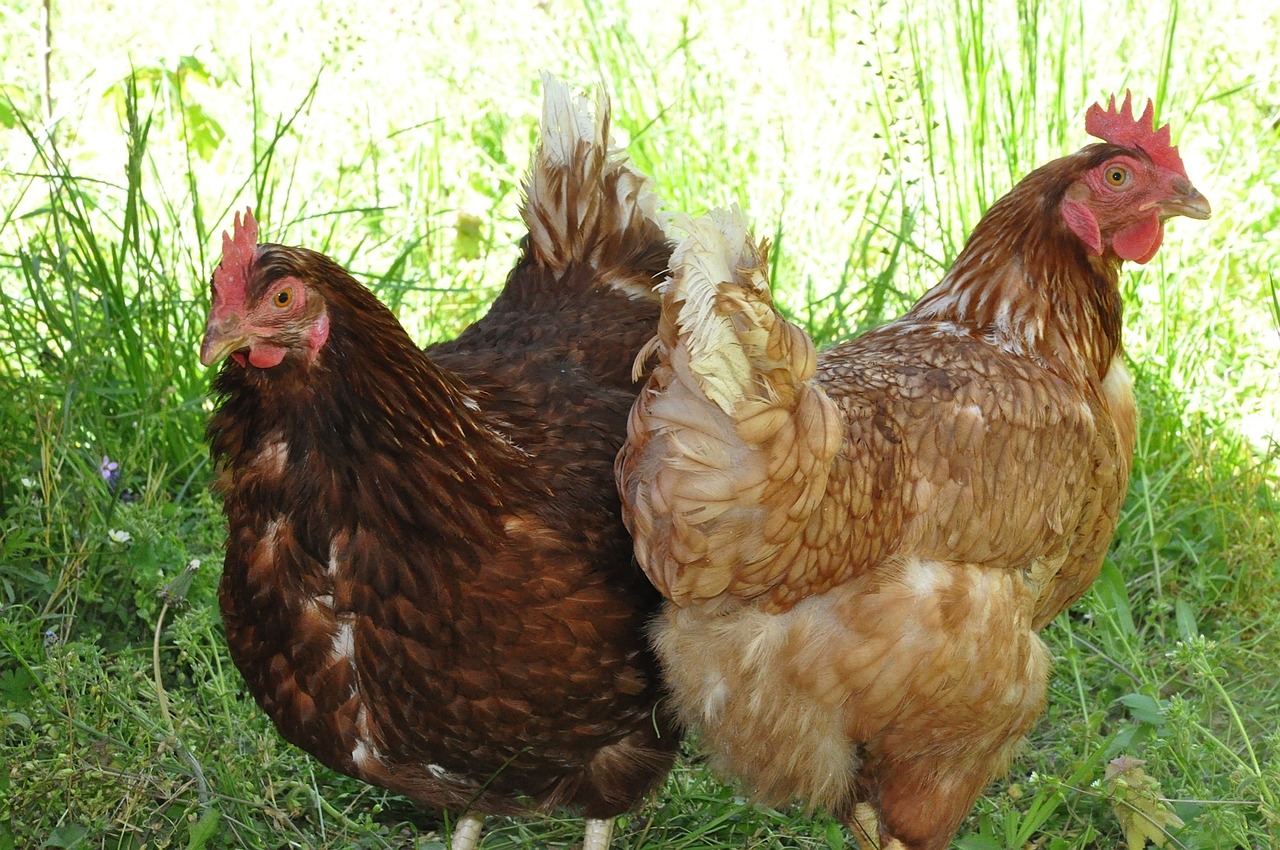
<box><xmin>617</xmin><ymin>207</ymin><xmax>842</xmax><ymax>614</ymax></box>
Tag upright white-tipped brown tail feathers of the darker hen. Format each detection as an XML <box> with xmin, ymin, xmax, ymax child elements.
<box><xmin>521</xmin><ymin>73</ymin><xmax>669</xmax><ymax>301</ymax></box>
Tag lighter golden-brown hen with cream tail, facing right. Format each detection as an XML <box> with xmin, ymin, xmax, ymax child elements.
<box><xmin>617</xmin><ymin>92</ymin><xmax>1210</xmax><ymax>850</ymax></box>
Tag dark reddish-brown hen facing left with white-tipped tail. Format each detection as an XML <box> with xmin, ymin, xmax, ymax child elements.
<box><xmin>201</xmin><ymin>78</ymin><xmax>678</xmax><ymax>850</ymax></box>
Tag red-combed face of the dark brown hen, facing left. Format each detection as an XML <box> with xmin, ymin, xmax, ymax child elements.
<box><xmin>200</xmin><ymin>210</ymin><xmax>329</xmax><ymax>369</ymax></box>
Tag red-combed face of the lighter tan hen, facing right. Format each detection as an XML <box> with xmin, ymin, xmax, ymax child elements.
<box><xmin>1061</xmin><ymin>92</ymin><xmax>1210</xmax><ymax>262</ymax></box>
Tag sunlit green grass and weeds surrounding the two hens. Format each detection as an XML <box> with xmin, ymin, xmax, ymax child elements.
<box><xmin>0</xmin><ymin>0</ymin><xmax>1280</xmax><ymax>850</ymax></box>
